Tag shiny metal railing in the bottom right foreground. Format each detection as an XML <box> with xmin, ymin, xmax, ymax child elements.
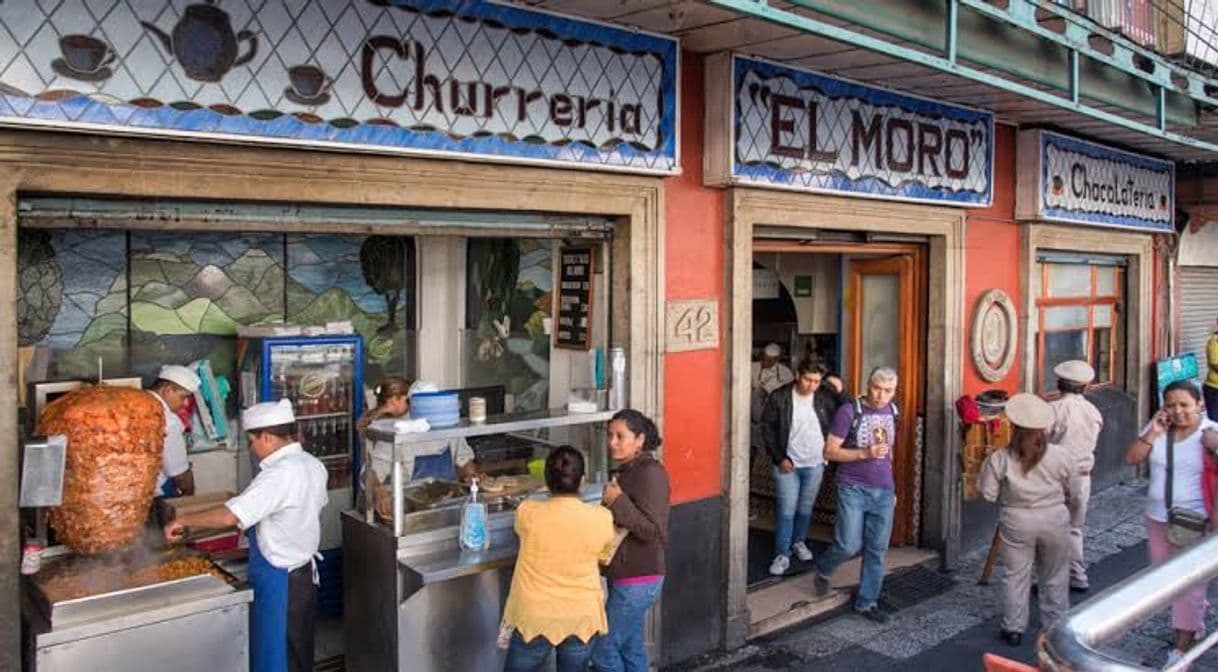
<box><xmin>1037</xmin><ymin>536</ymin><xmax>1218</xmax><ymax>672</ymax></box>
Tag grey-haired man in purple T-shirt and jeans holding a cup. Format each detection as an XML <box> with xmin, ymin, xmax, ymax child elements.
<box><xmin>812</xmin><ymin>366</ymin><xmax>898</xmax><ymax>623</ymax></box>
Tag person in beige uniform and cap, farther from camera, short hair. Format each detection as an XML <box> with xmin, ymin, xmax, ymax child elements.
<box><xmin>1049</xmin><ymin>359</ymin><xmax>1104</xmax><ymax>593</ymax></box>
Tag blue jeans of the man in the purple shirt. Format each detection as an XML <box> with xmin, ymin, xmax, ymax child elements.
<box><xmin>816</xmin><ymin>483</ymin><xmax>896</xmax><ymax>611</ymax></box>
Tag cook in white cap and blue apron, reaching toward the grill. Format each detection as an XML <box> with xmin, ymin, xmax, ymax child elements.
<box><xmin>164</xmin><ymin>399</ymin><xmax>326</xmax><ymax>672</ymax></box>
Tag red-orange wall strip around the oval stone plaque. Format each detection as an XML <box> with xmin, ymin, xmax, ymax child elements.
<box><xmin>962</xmin><ymin>124</ymin><xmax>1023</xmax><ymax>394</ymax></box>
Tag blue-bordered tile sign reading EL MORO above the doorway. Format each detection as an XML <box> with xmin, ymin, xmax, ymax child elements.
<box><xmin>721</xmin><ymin>56</ymin><xmax>994</xmax><ymax>206</ymax></box>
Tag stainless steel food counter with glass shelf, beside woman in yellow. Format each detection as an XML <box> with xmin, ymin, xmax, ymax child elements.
<box><xmin>342</xmin><ymin>410</ymin><xmax>613</xmax><ymax>672</ymax></box>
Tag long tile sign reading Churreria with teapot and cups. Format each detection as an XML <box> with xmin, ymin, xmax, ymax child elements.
<box><xmin>0</xmin><ymin>0</ymin><xmax>678</xmax><ymax>173</ymax></box>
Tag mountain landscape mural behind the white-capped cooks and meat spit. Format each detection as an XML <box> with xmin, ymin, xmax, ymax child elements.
<box><xmin>18</xmin><ymin>229</ymin><xmax>413</xmax><ymax>389</ymax></box>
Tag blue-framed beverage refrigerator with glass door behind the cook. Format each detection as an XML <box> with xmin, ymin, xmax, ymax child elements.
<box><xmin>238</xmin><ymin>335</ymin><xmax>364</xmax><ymax>614</ymax></box>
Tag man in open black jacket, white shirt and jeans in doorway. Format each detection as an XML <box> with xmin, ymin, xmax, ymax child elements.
<box><xmin>761</xmin><ymin>359</ymin><xmax>840</xmax><ymax>576</ymax></box>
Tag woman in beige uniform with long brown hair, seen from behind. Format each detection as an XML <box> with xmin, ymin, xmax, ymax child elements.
<box><xmin>977</xmin><ymin>394</ymin><xmax>1079</xmax><ymax>646</ymax></box>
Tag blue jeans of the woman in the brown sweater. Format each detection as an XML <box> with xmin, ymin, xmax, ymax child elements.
<box><xmin>592</xmin><ymin>578</ymin><xmax>664</xmax><ymax>672</ymax></box>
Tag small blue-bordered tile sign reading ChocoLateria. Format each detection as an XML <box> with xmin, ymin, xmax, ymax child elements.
<box><xmin>1016</xmin><ymin>130</ymin><xmax>1175</xmax><ymax>231</ymax></box>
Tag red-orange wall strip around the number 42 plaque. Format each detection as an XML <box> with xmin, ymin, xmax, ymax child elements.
<box><xmin>664</xmin><ymin>52</ymin><xmax>728</xmax><ymax>504</ymax></box>
